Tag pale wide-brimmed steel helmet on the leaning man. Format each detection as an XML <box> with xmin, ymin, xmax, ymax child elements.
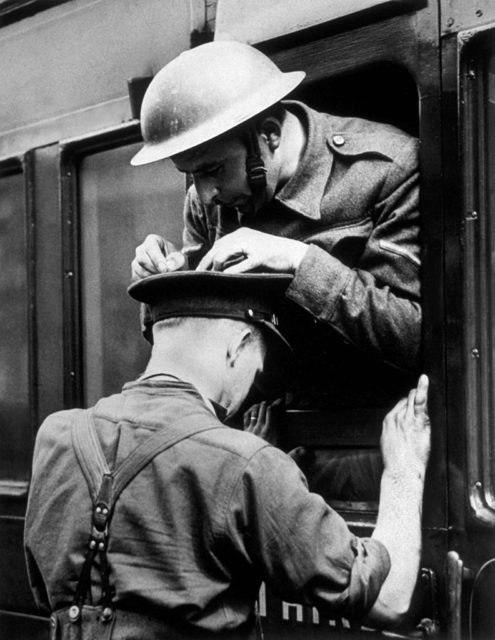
<box><xmin>131</xmin><ymin>41</ymin><xmax>305</xmax><ymax>165</ymax></box>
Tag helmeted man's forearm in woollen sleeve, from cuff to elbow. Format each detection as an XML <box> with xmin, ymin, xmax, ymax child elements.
<box><xmin>287</xmin><ymin>245</ymin><xmax>421</xmax><ymax>369</ymax></box>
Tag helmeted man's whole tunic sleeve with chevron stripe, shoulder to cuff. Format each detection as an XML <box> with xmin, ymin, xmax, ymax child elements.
<box><xmin>287</xmin><ymin>141</ymin><xmax>422</xmax><ymax>370</ymax></box>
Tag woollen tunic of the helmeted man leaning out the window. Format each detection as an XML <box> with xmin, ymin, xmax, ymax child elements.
<box><xmin>184</xmin><ymin>101</ymin><xmax>421</xmax><ymax>370</ymax></box>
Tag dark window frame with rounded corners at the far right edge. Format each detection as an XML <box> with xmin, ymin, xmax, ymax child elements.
<box><xmin>458</xmin><ymin>24</ymin><xmax>495</xmax><ymax>526</ymax></box>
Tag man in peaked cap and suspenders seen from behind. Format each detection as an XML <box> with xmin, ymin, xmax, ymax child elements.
<box><xmin>25</xmin><ymin>273</ymin><xmax>429</xmax><ymax>640</ymax></box>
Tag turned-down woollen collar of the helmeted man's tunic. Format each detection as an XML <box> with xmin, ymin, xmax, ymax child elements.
<box><xmin>275</xmin><ymin>100</ymin><xmax>333</xmax><ymax>220</ymax></box>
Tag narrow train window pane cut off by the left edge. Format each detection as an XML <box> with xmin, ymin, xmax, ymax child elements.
<box><xmin>0</xmin><ymin>163</ymin><xmax>31</xmax><ymax>493</ymax></box>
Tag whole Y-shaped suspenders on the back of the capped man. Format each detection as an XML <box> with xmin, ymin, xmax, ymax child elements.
<box><xmin>69</xmin><ymin>409</ymin><xmax>224</xmax><ymax>622</ymax></box>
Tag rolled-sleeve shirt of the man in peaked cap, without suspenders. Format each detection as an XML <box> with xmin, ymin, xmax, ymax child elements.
<box><xmin>25</xmin><ymin>377</ymin><xmax>389</xmax><ymax>638</ymax></box>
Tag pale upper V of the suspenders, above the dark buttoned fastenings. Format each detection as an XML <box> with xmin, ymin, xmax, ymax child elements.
<box><xmin>72</xmin><ymin>409</ymin><xmax>225</xmax><ymax>510</ymax></box>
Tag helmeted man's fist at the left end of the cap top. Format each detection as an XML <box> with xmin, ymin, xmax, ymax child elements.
<box><xmin>131</xmin><ymin>234</ymin><xmax>185</xmax><ymax>280</ymax></box>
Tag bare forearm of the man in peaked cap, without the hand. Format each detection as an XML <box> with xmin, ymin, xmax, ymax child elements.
<box><xmin>368</xmin><ymin>470</ymin><xmax>424</xmax><ymax>627</ymax></box>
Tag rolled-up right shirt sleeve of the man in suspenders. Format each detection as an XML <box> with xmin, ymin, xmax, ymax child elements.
<box><xmin>226</xmin><ymin>447</ymin><xmax>390</xmax><ymax>619</ymax></box>
